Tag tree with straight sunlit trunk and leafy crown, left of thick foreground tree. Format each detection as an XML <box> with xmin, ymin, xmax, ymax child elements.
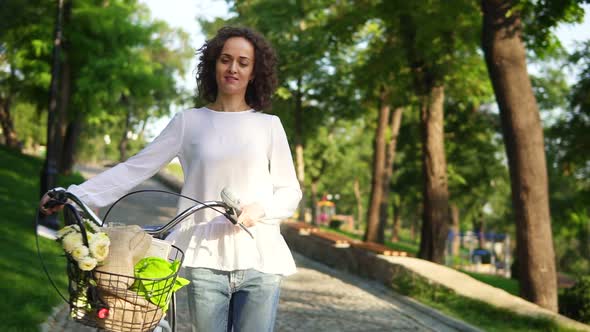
<box><xmin>394</xmin><ymin>1</ymin><xmax>486</xmax><ymax>263</ymax></box>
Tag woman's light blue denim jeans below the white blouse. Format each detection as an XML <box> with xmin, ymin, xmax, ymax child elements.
<box><xmin>186</xmin><ymin>267</ymin><xmax>281</xmax><ymax>332</ymax></box>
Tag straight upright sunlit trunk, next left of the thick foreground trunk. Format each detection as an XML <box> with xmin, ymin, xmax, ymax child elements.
<box><xmin>418</xmin><ymin>86</ymin><xmax>449</xmax><ymax>264</ymax></box>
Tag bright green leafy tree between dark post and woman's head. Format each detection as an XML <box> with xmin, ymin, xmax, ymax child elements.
<box><xmin>56</xmin><ymin>1</ymin><xmax>192</xmax><ymax>173</ymax></box>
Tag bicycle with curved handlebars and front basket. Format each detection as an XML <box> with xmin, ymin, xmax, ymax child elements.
<box><xmin>35</xmin><ymin>188</ymin><xmax>252</xmax><ymax>332</ymax></box>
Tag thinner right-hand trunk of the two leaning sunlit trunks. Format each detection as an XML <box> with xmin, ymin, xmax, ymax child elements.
<box><xmin>378</xmin><ymin>107</ymin><xmax>403</xmax><ymax>243</ymax></box>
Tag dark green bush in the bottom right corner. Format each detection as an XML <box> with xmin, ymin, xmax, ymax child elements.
<box><xmin>559</xmin><ymin>276</ymin><xmax>590</xmax><ymax>324</ymax></box>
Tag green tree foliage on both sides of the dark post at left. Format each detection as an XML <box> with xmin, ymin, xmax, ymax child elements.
<box><xmin>0</xmin><ymin>0</ymin><xmax>192</xmax><ymax>162</ymax></box>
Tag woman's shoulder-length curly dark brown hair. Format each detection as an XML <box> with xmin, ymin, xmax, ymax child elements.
<box><xmin>196</xmin><ymin>26</ymin><xmax>277</xmax><ymax>111</ymax></box>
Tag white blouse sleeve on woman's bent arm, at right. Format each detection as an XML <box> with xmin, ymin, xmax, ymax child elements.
<box><xmin>264</xmin><ymin>116</ymin><xmax>301</xmax><ymax>222</ymax></box>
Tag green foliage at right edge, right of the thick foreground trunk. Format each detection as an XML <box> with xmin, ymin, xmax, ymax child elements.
<box><xmin>545</xmin><ymin>42</ymin><xmax>590</xmax><ymax>276</ymax></box>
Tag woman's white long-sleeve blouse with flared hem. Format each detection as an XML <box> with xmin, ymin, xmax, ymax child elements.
<box><xmin>68</xmin><ymin>107</ymin><xmax>301</xmax><ymax>275</ymax></box>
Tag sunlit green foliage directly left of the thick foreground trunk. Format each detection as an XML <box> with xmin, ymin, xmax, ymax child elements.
<box><xmin>445</xmin><ymin>102</ymin><xmax>510</xmax><ymax>232</ymax></box>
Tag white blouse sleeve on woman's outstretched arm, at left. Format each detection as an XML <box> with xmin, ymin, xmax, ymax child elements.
<box><xmin>68</xmin><ymin>112</ymin><xmax>184</xmax><ymax>208</ymax></box>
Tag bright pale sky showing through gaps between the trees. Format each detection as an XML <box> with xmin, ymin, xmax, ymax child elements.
<box><xmin>140</xmin><ymin>0</ymin><xmax>590</xmax><ymax>136</ymax></box>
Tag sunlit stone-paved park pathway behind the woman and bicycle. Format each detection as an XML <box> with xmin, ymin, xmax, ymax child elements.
<box><xmin>42</xmin><ymin>167</ymin><xmax>476</xmax><ymax>332</ymax></box>
